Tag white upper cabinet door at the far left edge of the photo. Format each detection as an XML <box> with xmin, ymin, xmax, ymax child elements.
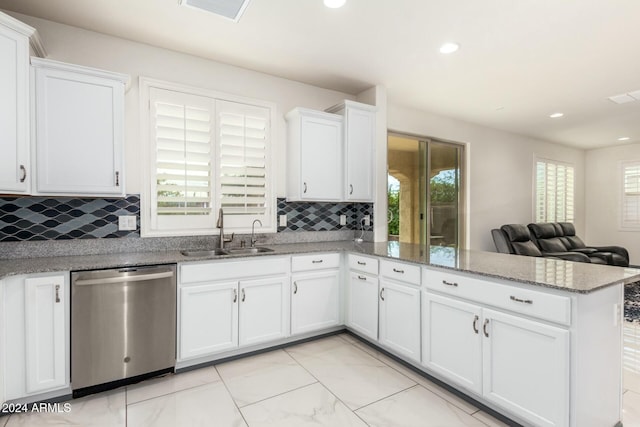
<box><xmin>0</xmin><ymin>24</ymin><xmax>31</xmax><ymax>193</ymax></box>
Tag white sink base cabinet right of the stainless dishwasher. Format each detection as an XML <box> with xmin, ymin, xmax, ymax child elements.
<box><xmin>178</xmin><ymin>258</ymin><xmax>289</xmax><ymax>362</ymax></box>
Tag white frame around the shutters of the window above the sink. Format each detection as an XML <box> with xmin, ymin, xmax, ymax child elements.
<box><xmin>139</xmin><ymin>76</ymin><xmax>277</xmax><ymax>237</ymax></box>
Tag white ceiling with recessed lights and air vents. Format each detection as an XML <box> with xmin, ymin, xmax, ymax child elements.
<box><xmin>0</xmin><ymin>0</ymin><xmax>640</xmax><ymax>149</ymax></box>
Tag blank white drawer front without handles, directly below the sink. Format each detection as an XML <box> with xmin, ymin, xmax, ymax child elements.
<box><xmin>179</xmin><ymin>256</ymin><xmax>289</xmax><ymax>284</ymax></box>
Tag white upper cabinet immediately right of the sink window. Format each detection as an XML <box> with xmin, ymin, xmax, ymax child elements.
<box><xmin>286</xmin><ymin>108</ymin><xmax>343</xmax><ymax>201</ymax></box>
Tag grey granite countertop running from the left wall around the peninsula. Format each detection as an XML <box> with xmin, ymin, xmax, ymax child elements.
<box><xmin>0</xmin><ymin>241</ymin><xmax>640</xmax><ymax>293</ymax></box>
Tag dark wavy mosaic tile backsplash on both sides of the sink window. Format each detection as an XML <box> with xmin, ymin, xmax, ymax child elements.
<box><xmin>0</xmin><ymin>194</ymin><xmax>373</xmax><ymax>242</ymax></box>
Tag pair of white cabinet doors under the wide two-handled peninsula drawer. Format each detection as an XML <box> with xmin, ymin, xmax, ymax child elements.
<box><xmin>422</xmin><ymin>291</ymin><xmax>569</xmax><ymax>427</ymax></box>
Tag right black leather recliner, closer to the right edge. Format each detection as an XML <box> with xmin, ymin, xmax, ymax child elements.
<box><xmin>528</xmin><ymin>222</ymin><xmax>629</xmax><ymax>267</ymax></box>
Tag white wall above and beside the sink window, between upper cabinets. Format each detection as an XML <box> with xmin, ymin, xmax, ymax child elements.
<box><xmin>13</xmin><ymin>12</ymin><xmax>354</xmax><ymax>197</ymax></box>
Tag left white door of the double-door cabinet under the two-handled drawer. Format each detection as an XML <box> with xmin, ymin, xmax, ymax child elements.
<box><xmin>422</xmin><ymin>291</ymin><xmax>482</xmax><ymax>394</ymax></box>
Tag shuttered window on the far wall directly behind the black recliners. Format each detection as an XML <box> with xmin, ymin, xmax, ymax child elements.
<box><xmin>535</xmin><ymin>159</ymin><xmax>575</xmax><ymax>222</ymax></box>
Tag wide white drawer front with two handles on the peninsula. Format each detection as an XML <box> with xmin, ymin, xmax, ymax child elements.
<box><xmin>423</xmin><ymin>268</ymin><xmax>571</xmax><ymax>326</ymax></box>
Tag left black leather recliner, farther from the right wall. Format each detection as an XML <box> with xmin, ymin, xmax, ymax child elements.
<box><xmin>491</xmin><ymin>224</ymin><xmax>591</xmax><ymax>262</ymax></box>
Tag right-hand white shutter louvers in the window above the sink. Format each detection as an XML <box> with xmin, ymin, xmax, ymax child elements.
<box><xmin>217</xmin><ymin>102</ymin><xmax>269</xmax><ymax>216</ymax></box>
